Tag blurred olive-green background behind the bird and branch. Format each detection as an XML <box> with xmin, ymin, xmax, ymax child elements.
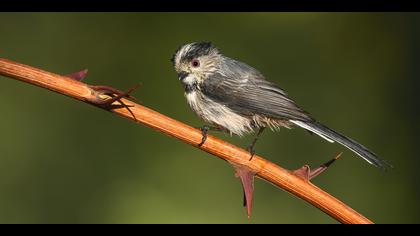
<box><xmin>0</xmin><ymin>13</ymin><xmax>420</xmax><ymax>223</ymax></box>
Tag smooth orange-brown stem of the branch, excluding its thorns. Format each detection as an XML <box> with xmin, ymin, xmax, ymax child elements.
<box><xmin>0</xmin><ymin>58</ymin><xmax>372</xmax><ymax>224</ymax></box>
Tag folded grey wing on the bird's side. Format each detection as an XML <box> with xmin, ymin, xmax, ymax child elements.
<box><xmin>200</xmin><ymin>59</ymin><xmax>313</xmax><ymax>121</ymax></box>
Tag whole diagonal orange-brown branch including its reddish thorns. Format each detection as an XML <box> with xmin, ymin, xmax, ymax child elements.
<box><xmin>0</xmin><ymin>58</ymin><xmax>373</xmax><ymax>224</ymax></box>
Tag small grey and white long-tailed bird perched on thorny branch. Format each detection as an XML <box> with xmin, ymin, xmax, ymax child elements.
<box><xmin>171</xmin><ymin>42</ymin><xmax>391</xmax><ymax>169</ymax></box>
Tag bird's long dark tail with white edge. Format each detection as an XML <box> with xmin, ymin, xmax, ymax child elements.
<box><xmin>290</xmin><ymin>120</ymin><xmax>392</xmax><ymax>169</ymax></box>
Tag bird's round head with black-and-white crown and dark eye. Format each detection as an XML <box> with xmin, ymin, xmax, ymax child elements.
<box><xmin>172</xmin><ymin>42</ymin><xmax>221</xmax><ymax>84</ymax></box>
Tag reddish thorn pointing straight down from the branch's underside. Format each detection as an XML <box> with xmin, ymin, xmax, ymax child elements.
<box><xmin>232</xmin><ymin>164</ymin><xmax>256</xmax><ymax>218</ymax></box>
